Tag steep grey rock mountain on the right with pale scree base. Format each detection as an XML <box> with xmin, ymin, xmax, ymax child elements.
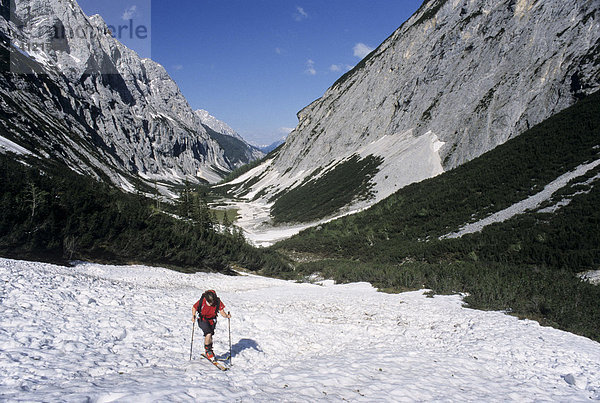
<box><xmin>231</xmin><ymin>0</ymin><xmax>600</xmax><ymax>227</ymax></box>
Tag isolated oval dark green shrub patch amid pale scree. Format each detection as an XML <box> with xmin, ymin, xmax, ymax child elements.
<box><xmin>271</xmin><ymin>155</ymin><xmax>382</xmax><ymax>223</ymax></box>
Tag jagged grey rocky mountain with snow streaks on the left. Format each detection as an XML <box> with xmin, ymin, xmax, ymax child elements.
<box><xmin>0</xmin><ymin>0</ymin><xmax>256</xmax><ymax>190</ymax></box>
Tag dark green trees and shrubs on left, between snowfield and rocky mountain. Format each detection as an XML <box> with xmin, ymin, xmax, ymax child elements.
<box><xmin>0</xmin><ymin>154</ymin><xmax>289</xmax><ymax>272</ymax></box>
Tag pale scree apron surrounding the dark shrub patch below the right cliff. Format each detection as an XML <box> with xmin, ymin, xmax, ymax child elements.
<box><xmin>226</xmin><ymin>130</ymin><xmax>444</xmax><ymax>246</ymax></box>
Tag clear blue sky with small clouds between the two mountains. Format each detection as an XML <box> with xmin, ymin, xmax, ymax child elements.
<box><xmin>79</xmin><ymin>0</ymin><xmax>422</xmax><ymax>144</ymax></box>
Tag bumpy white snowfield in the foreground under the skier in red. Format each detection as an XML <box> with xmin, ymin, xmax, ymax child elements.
<box><xmin>0</xmin><ymin>259</ymin><xmax>600</xmax><ymax>402</ymax></box>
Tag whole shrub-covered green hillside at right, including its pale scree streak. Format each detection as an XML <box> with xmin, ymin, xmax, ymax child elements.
<box><xmin>271</xmin><ymin>92</ymin><xmax>600</xmax><ymax>340</ymax></box>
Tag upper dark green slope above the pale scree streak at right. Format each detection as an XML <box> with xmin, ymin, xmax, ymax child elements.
<box><xmin>278</xmin><ymin>90</ymin><xmax>600</xmax><ymax>262</ymax></box>
